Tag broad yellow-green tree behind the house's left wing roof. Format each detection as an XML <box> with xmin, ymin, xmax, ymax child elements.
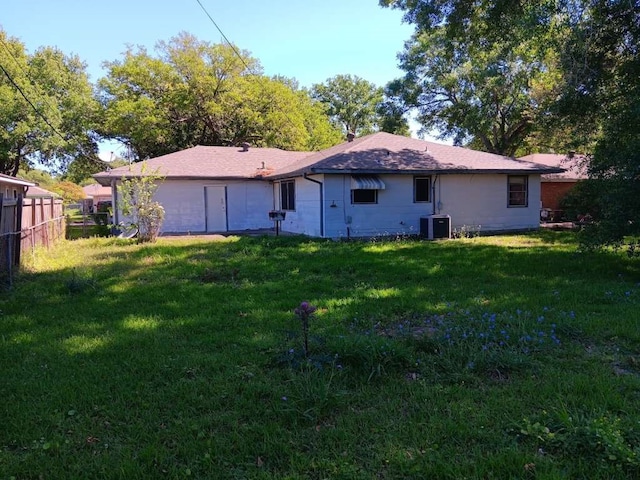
<box><xmin>99</xmin><ymin>33</ymin><xmax>340</xmax><ymax>160</ymax></box>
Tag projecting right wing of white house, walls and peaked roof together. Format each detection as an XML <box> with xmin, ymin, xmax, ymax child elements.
<box><xmin>269</xmin><ymin>133</ymin><xmax>562</xmax><ymax>238</ymax></box>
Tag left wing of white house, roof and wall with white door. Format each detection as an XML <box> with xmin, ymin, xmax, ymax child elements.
<box><xmin>93</xmin><ymin>145</ymin><xmax>310</xmax><ymax>233</ymax></box>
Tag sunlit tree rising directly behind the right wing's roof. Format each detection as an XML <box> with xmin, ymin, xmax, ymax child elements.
<box><xmin>380</xmin><ymin>2</ymin><xmax>561</xmax><ymax>156</ymax></box>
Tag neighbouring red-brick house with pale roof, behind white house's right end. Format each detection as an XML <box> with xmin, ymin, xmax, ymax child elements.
<box><xmin>520</xmin><ymin>153</ymin><xmax>587</xmax><ymax>221</ymax></box>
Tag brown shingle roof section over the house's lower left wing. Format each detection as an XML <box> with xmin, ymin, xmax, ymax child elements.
<box><xmin>93</xmin><ymin>145</ymin><xmax>310</xmax><ymax>185</ymax></box>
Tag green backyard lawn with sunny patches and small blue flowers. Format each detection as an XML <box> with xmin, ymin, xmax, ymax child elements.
<box><xmin>0</xmin><ymin>232</ymin><xmax>640</xmax><ymax>479</ymax></box>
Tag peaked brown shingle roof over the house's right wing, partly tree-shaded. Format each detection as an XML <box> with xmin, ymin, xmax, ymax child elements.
<box><xmin>271</xmin><ymin>132</ymin><xmax>562</xmax><ymax>178</ymax></box>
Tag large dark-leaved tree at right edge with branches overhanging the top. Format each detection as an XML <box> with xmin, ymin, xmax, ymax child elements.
<box><xmin>380</xmin><ymin>0</ymin><xmax>640</xmax><ymax>244</ymax></box>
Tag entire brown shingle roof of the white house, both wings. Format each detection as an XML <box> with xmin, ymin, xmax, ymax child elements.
<box><xmin>93</xmin><ymin>136</ymin><xmax>563</xmax><ymax>185</ymax></box>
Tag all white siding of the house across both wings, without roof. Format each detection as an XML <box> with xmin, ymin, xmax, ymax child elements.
<box><xmin>114</xmin><ymin>174</ymin><xmax>540</xmax><ymax>238</ymax></box>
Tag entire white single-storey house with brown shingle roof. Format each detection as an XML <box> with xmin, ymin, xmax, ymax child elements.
<box><xmin>94</xmin><ymin>132</ymin><xmax>562</xmax><ymax>238</ymax></box>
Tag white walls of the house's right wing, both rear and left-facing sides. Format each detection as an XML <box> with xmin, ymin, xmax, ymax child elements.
<box><xmin>274</xmin><ymin>174</ymin><xmax>540</xmax><ymax>238</ymax></box>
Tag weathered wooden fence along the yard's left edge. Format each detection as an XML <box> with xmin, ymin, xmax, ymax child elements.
<box><xmin>0</xmin><ymin>194</ymin><xmax>65</xmax><ymax>285</ymax></box>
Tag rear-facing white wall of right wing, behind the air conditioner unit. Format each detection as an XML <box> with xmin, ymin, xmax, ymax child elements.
<box><xmin>324</xmin><ymin>174</ymin><xmax>540</xmax><ymax>238</ymax></box>
